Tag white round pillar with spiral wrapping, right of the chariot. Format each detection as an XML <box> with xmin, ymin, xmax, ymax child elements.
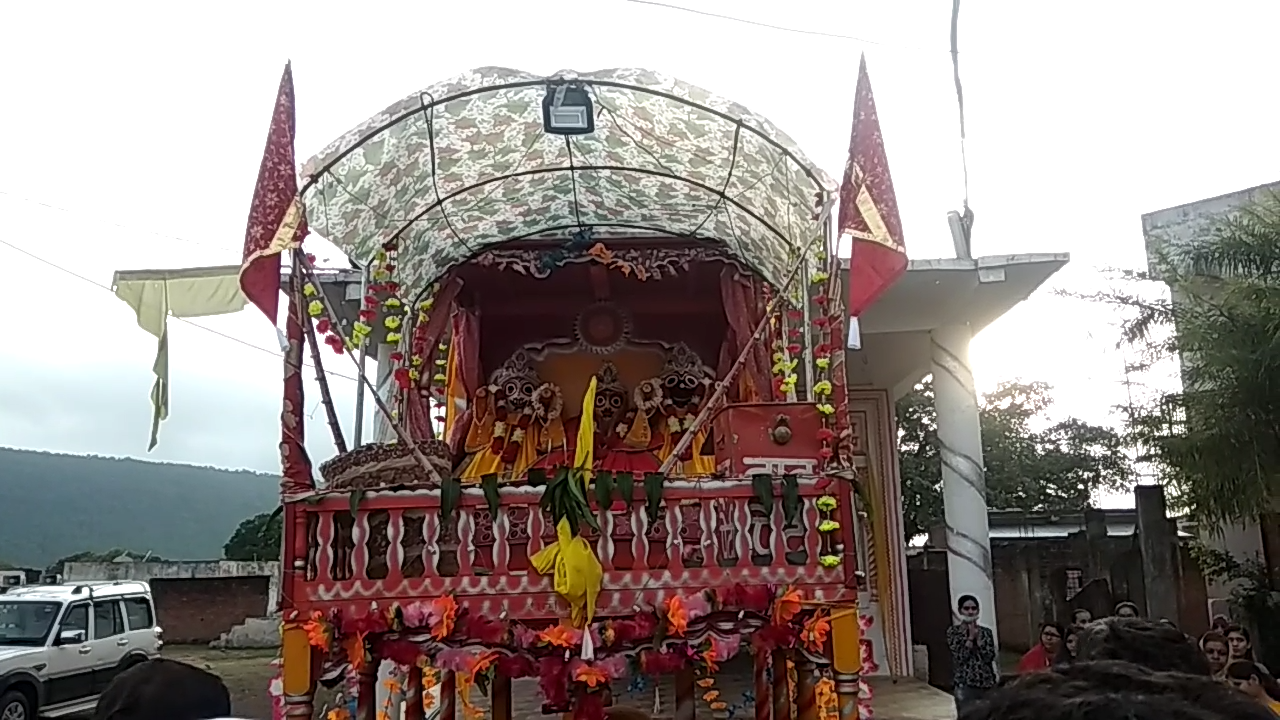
<box><xmin>929</xmin><ymin>325</ymin><xmax>998</xmax><ymax>642</ymax></box>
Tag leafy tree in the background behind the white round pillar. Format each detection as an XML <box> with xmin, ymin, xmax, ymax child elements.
<box><xmin>897</xmin><ymin>378</ymin><xmax>1134</xmax><ymax>538</ymax></box>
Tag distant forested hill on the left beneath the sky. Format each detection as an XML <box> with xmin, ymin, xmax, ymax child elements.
<box><xmin>0</xmin><ymin>448</ymin><xmax>279</xmax><ymax>568</ymax></box>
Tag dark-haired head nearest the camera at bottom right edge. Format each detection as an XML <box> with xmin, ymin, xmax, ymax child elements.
<box><xmin>959</xmin><ymin>661</ymin><xmax>1275</xmax><ymax>720</ymax></box>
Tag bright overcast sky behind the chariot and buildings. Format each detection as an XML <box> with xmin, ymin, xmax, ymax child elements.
<box><xmin>0</xmin><ymin>0</ymin><xmax>1280</xmax><ymax>473</ymax></box>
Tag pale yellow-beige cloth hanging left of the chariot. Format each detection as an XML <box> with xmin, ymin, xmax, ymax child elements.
<box><xmin>111</xmin><ymin>265</ymin><xmax>248</xmax><ymax>452</ymax></box>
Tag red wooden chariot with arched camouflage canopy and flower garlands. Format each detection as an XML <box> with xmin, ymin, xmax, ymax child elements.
<box><xmin>122</xmin><ymin>60</ymin><xmax>905</xmax><ymax>720</ymax></box>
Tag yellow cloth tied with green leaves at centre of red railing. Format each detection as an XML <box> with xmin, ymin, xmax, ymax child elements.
<box><xmin>530</xmin><ymin>378</ymin><xmax>604</xmax><ymax>660</ymax></box>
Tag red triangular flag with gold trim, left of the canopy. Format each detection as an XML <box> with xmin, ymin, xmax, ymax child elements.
<box><xmin>241</xmin><ymin>64</ymin><xmax>307</xmax><ymax>324</ymax></box>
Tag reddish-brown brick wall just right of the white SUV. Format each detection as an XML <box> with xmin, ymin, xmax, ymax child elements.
<box><xmin>151</xmin><ymin>575</ymin><xmax>270</xmax><ymax>643</ymax></box>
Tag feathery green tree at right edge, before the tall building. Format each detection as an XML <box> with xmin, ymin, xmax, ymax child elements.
<box><xmin>1088</xmin><ymin>197</ymin><xmax>1280</xmax><ymax>528</ymax></box>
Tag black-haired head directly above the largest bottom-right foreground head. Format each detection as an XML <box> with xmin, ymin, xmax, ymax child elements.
<box><xmin>1075</xmin><ymin>609</ymin><xmax>1212</xmax><ymax>676</ymax></box>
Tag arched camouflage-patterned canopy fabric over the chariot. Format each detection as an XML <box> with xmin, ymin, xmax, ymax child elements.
<box><xmin>302</xmin><ymin>68</ymin><xmax>835</xmax><ymax>292</ymax></box>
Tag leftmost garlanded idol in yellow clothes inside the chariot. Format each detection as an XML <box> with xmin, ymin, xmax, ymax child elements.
<box><xmin>458</xmin><ymin>351</ymin><xmax>566</xmax><ymax>483</ymax></box>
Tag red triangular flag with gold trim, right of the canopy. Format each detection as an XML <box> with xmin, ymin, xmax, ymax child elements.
<box><xmin>840</xmin><ymin>55</ymin><xmax>906</xmax><ymax>318</ymax></box>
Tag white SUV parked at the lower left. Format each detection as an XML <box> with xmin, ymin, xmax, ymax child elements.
<box><xmin>0</xmin><ymin>583</ymin><xmax>161</xmax><ymax>720</ymax></box>
